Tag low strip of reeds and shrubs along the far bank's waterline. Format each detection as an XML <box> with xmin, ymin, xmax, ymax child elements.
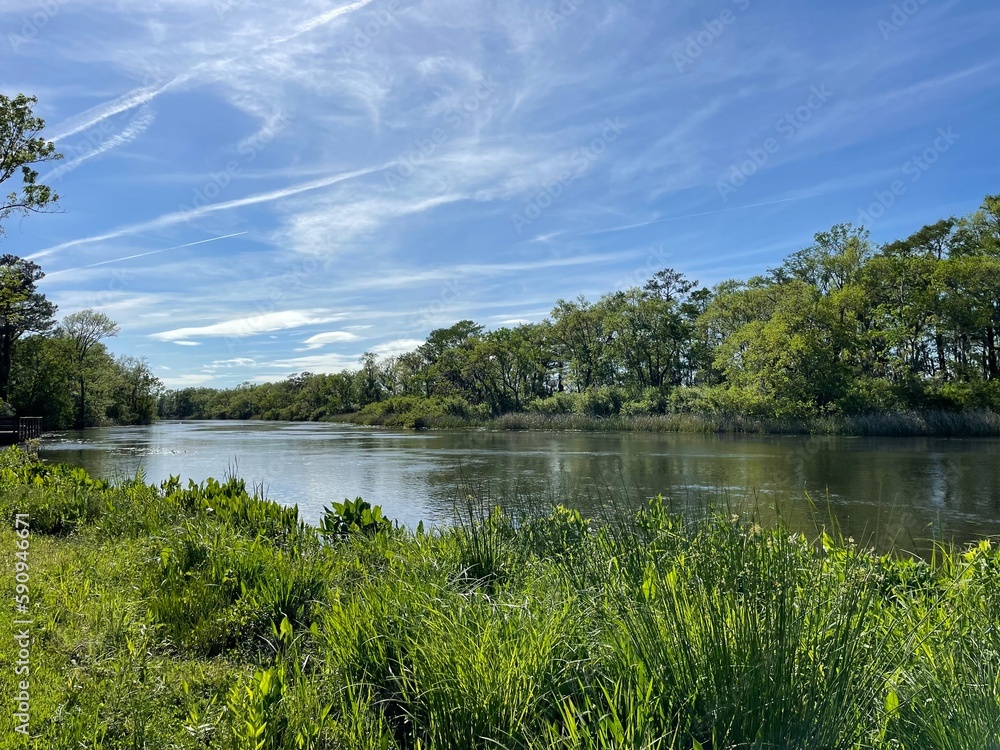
<box><xmin>324</xmin><ymin>407</ymin><xmax>1000</xmax><ymax>437</ymax></box>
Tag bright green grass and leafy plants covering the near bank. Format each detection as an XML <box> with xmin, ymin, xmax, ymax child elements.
<box><xmin>0</xmin><ymin>450</ymin><xmax>1000</xmax><ymax>750</ymax></box>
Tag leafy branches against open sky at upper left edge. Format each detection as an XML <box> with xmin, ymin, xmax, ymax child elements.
<box><xmin>0</xmin><ymin>94</ymin><xmax>62</xmax><ymax>236</ymax></box>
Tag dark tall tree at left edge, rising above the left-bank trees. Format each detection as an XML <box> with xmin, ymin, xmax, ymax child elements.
<box><xmin>0</xmin><ymin>255</ymin><xmax>56</xmax><ymax>401</ymax></box>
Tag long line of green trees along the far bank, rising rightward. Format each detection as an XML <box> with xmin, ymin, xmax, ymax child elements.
<box><xmin>158</xmin><ymin>196</ymin><xmax>1000</xmax><ymax>428</ymax></box>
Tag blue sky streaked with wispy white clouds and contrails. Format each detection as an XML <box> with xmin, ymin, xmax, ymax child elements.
<box><xmin>0</xmin><ymin>0</ymin><xmax>1000</xmax><ymax>388</ymax></box>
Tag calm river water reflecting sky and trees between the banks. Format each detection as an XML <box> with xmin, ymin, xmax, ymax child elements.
<box><xmin>35</xmin><ymin>422</ymin><xmax>1000</xmax><ymax>548</ymax></box>
